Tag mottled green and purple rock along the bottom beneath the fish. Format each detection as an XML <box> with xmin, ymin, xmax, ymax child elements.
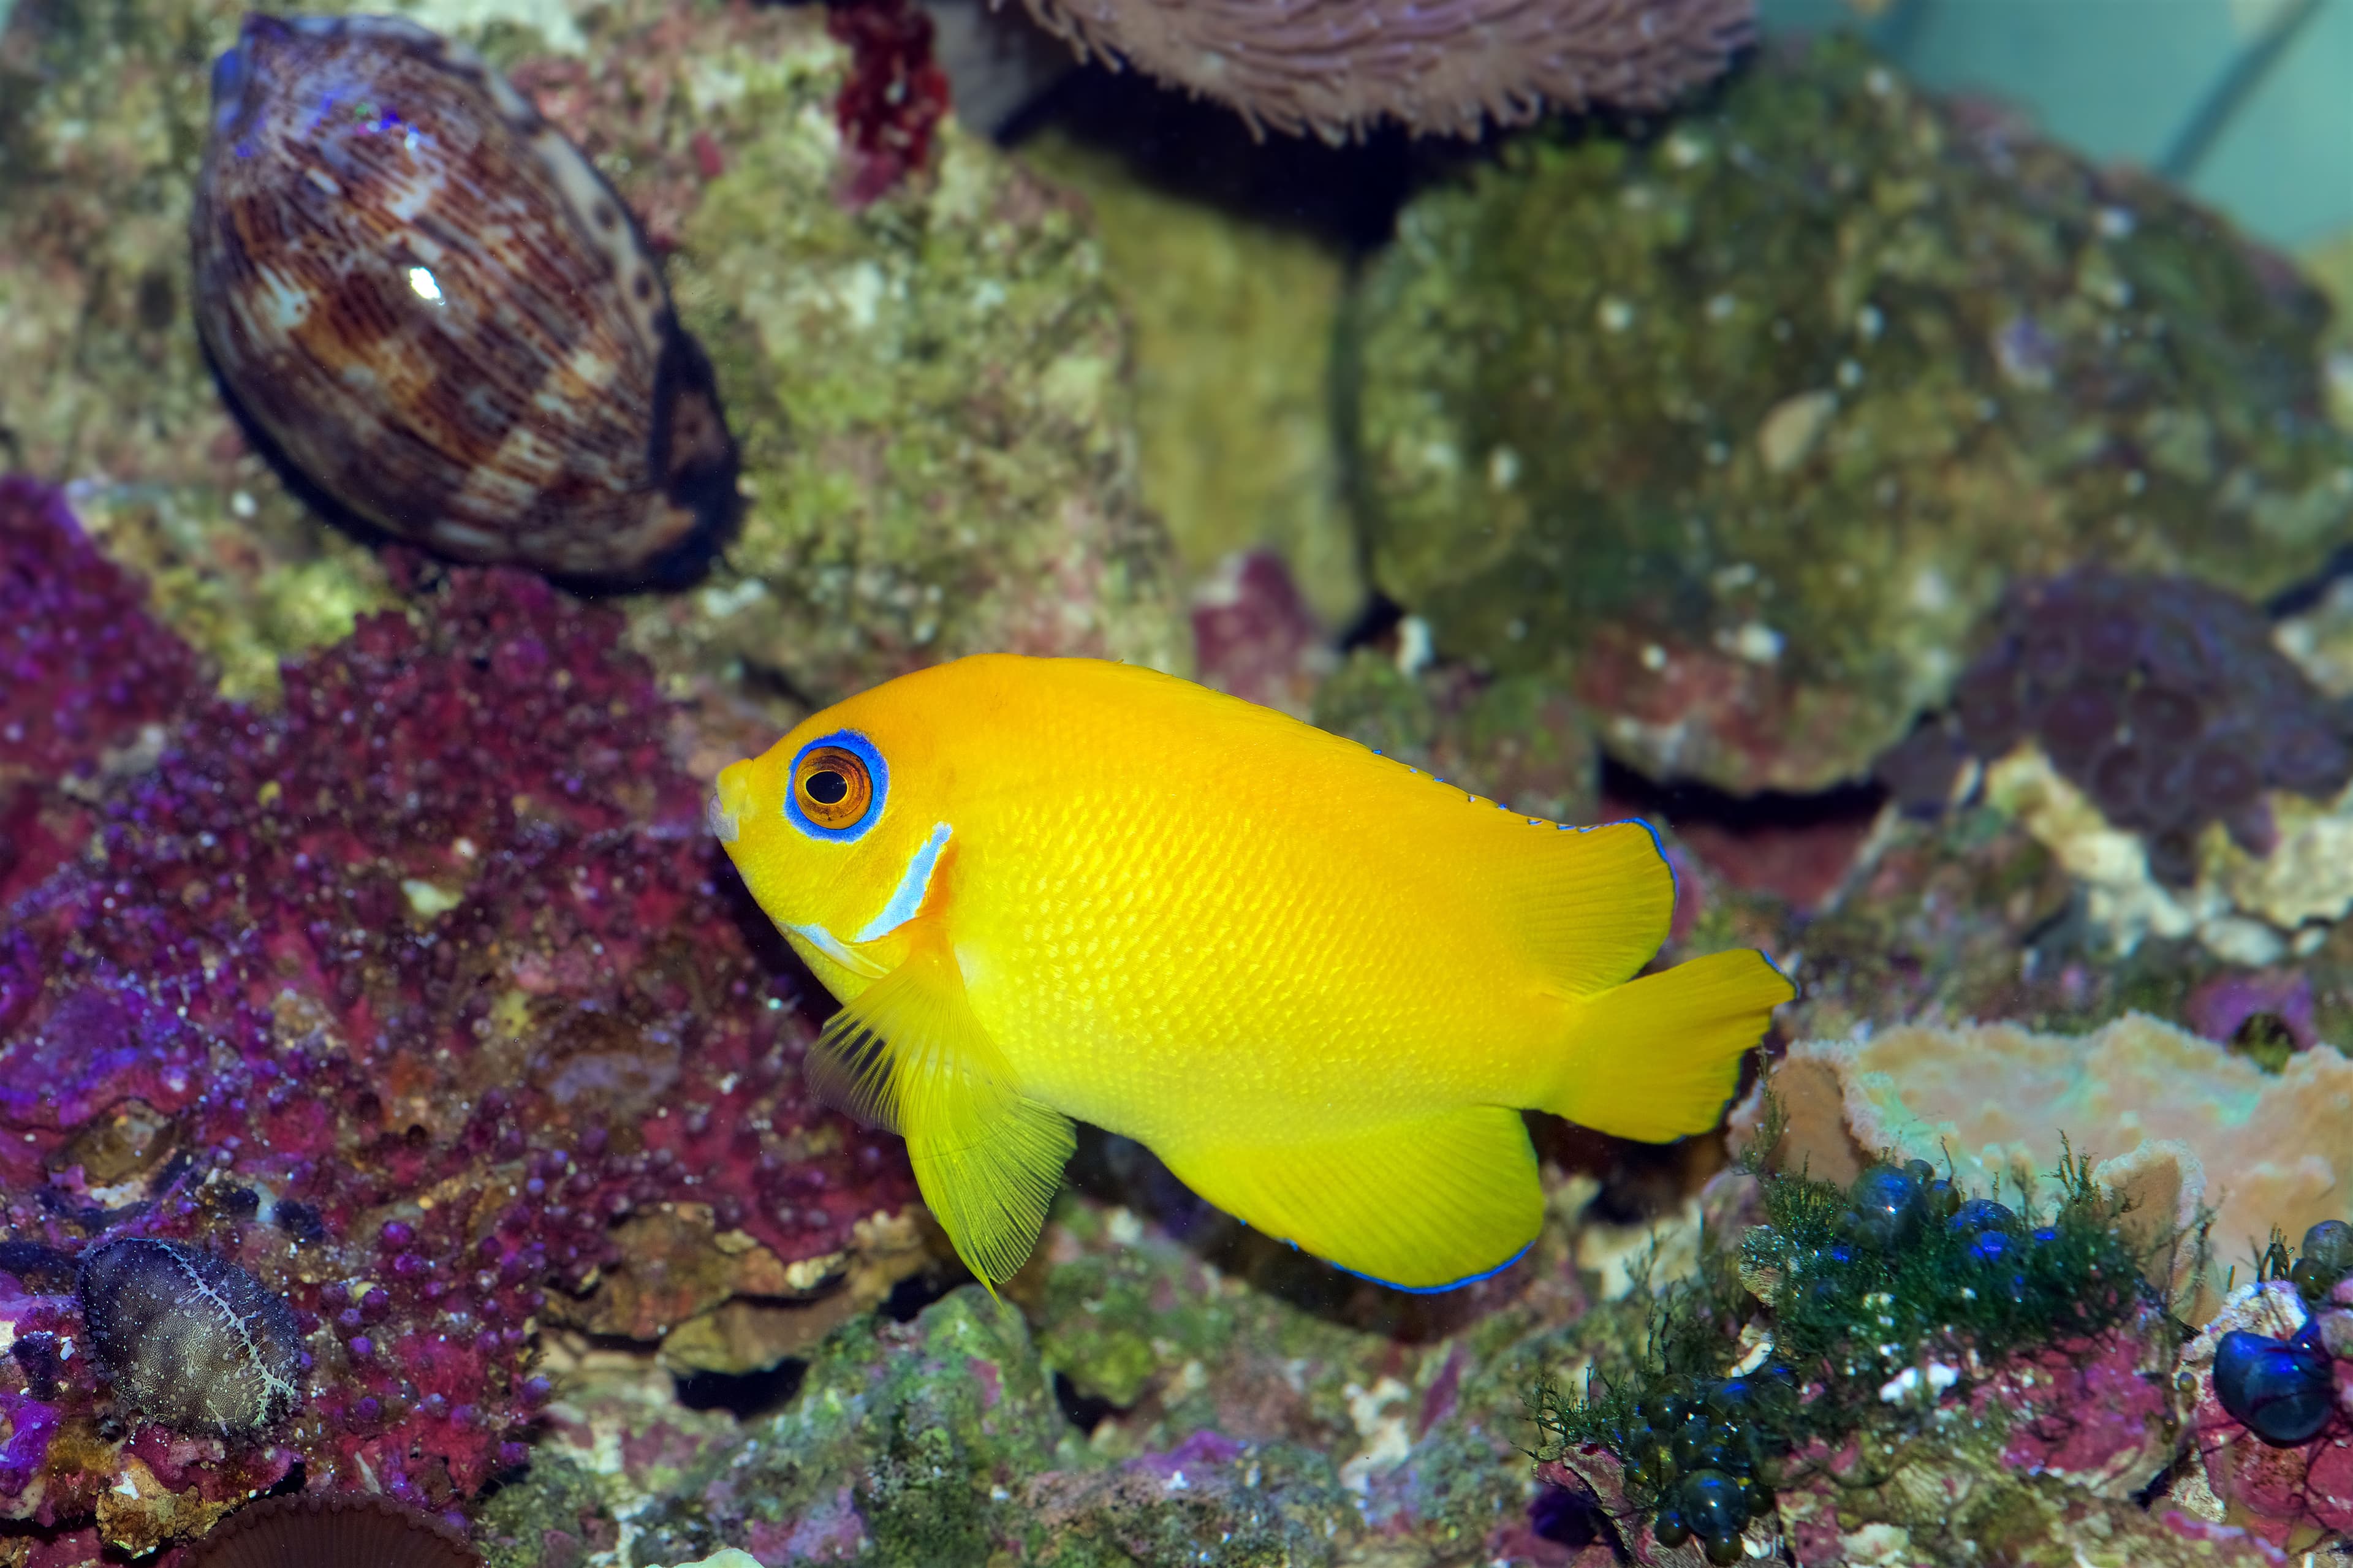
<box><xmin>478</xmin><ymin>1140</ymin><xmax>1713</xmax><ymax>1568</ymax></box>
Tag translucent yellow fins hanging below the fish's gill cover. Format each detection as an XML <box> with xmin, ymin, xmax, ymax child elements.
<box><xmin>809</xmin><ymin>933</ymin><xmax>1073</xmax><ymax>1288</ymax></box>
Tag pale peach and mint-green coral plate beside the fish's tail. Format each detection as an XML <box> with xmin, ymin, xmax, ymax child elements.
<box><xmin>1734</xmin><ymin>1012</ymin><xmax>2353</xmax><ymax>1281</ymax></box>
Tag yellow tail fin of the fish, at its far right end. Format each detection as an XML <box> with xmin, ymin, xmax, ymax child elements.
<box><xmin>1539</xmin><ymin>949</ymin><xmax>1798</xmax><ymax>1142</ymax></box>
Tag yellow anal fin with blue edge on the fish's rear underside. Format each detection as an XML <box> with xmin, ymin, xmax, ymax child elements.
<box><xmin>1155</xmin><ymin>1107</ymin><xmax>1544</xmax><ymax>1290</ymax></box>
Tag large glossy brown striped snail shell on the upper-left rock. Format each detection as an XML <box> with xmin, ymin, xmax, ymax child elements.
<box><xmin>191</xmin><ymin>14</ymin><xmax>737</xmax><ymax>577</ymax></box>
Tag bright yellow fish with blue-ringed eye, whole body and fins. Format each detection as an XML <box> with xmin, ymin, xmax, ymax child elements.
<box><xmin>711</xmin><ymin>654</ymin><xmax>1793</xmax><ymax>1290</ymax></box>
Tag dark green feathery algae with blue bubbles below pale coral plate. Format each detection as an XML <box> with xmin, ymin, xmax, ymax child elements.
<box><xmin>1529</xmin><ymin>1144</ymin><xmax>2177</xmax><ymax>1561</ymax></box>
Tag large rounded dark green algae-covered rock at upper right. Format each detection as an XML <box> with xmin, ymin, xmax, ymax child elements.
<box><xmin>1353</xmin><ymin>40</ymin><xmax>2353</xmax><ymax>791</ymax></box>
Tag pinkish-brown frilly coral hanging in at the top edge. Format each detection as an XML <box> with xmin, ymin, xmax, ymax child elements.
<box><xmin>1028</xmin><ymin>0</ymin><xmax>1756</xmax><ymax>142</ymax></box>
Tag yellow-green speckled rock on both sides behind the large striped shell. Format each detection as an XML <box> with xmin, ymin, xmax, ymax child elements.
<box><xmin>0</xmin><ymin>0</ymin><xmax>1191</xmax><ymax>730</ymax></box>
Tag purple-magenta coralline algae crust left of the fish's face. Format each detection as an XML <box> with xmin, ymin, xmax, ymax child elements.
<box><xmin>0</xmin><ymin>485</ymin><xmax>913</xmax><ymax>1561</ymax></box>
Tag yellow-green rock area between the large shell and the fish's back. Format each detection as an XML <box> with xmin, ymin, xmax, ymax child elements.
<box><xmin>633</xmin><ymin>23</ymin><xmax>1191</xmax><ymax>702</ymax></box>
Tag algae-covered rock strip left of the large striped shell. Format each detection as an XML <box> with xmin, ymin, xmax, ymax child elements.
<box><xmin>0</xmin><ymin>0</ymin><xmax>393</xmax><ymax>699</ymax></box>
